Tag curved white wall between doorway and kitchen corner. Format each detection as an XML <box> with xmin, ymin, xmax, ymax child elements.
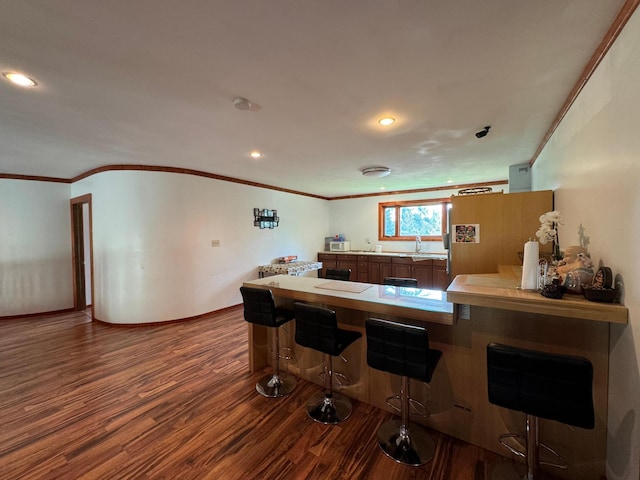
<box><xmin>72</xmin><ymin>171</ymin><xmax>328</xmax><ymax>323</ymax></box>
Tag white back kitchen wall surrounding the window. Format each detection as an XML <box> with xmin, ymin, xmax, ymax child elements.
<box><xmin>327</xmin><ymin>183</ymin><xmax>509</xmax><ymax>253</ymax></box>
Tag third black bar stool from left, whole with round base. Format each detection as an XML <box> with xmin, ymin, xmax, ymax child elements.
<box><xmin>365</xmin><ymin>318</ymin><xmax>442</xmax><ymax>466</ymax></box>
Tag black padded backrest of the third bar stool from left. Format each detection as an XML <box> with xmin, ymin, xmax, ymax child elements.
<box><xmin>365</xmin><ymin>318</ymin><xmax>442</xmax><ymax>383</ymax></box>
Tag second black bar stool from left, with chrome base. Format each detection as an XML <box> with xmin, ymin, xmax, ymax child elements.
<box><xmin>293</xmin><ymin>302</ymin><xmax>362</xmax><ymax>424</ymax></box>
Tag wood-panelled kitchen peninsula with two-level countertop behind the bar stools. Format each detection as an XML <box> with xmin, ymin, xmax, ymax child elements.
<box><xmin>244</xmin><ymin>267</ymin><xmax>626</xmax><ymax>480</ymax></box>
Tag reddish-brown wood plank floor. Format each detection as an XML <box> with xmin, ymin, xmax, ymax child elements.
<box><xmin>0</xmin><ymin>308</ymin><xmax>548</xmax><ymax>480</ymax></box>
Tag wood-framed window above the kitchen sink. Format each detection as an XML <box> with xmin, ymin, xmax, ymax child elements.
<box><xmin>378</xmin><ymin>198</ymin><xmax>451</xmax><ymax>241</ymax></box>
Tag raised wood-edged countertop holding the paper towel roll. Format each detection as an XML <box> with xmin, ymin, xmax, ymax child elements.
<box><xmin>447</xmin><ymin>266</ymin><xmax>628</xmax><ymax>325</ymax></box>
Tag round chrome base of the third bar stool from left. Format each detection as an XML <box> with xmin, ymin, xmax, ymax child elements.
<box><xmin>377</xmin><ymin>419</ymin><xmax>436</xmax><ymax>467</ymax></box>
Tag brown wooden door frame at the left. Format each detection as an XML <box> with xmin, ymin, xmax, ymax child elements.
<box><xmin>69</xmin><ymin>193</ymin><xmax>95</xmax><ymax>319</ymax></box>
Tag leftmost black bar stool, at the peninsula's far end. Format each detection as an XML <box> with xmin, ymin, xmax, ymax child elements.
<box><xmin>240</xmin><ymin>286</ymin><xmax>296</xmax><ymax>398</ymax></box>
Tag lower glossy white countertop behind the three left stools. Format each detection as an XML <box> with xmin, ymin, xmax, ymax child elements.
<box><xmin>244</xmin><ymin>275</ymin><xmax>453</xmax><ymax>325</ymax></box>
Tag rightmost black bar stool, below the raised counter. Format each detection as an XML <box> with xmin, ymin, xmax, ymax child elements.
<box><xmin>487</xmin><ymin>343</ymin><xmax>595</xmax><ymax>480</ymax></box>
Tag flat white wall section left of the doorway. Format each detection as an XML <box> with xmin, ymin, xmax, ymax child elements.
<box><xmin>0</xmin><ymin>179</ymin><xmax>73</xmax><ymax>316</ymax></box>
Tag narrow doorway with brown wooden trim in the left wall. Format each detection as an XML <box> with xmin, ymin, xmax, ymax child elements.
<box><xmin>71</xmin><ymin>194</ymin><xmax>94</xmax><ymax>319</ymax></box>
